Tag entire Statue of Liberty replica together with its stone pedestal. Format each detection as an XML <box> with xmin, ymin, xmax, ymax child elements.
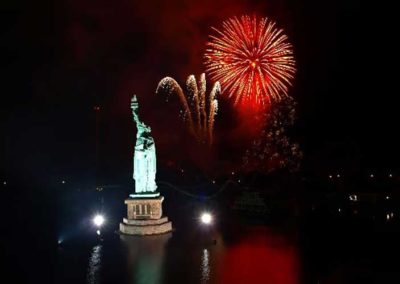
<box><xmin>120</xmin><ymin>96</ymin><xmax>172</xmax><ymax>235</ymax></box>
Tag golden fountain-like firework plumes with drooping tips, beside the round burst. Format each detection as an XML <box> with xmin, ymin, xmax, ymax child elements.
<box><xmin>156</xmin><ymin>73</ymin><xmax>221</xmax><ymax>145</ymax></box>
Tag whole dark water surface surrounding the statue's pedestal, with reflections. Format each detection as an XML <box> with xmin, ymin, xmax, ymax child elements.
<box><xmin>0</xmin><ymin>185</ymin><xmax>400</xmax><ymax>284</ymax></box>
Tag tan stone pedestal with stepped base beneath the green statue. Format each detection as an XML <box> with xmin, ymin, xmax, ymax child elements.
<box><xmin>119</xmin><ymin>196</ymin><xmax>172</xmax><ymax>235</ymax></box>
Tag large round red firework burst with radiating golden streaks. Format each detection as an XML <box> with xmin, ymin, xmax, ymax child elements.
<box><xmin>205</xmin><ymin>16</ymin><xmax>296</xmax><ymax>105</ymax></box>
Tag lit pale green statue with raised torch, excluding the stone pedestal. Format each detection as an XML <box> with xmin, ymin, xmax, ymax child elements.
<box><xmin>129</xmin><ymin>96</ymin><xmax>160</xmax><ymax>198</ymax></box>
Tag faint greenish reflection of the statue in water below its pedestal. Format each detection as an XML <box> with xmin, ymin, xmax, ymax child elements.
<box><xmin>120</xmin><ymin>234</ymin><xmax>171</xmax><ymax>284</ymax></box>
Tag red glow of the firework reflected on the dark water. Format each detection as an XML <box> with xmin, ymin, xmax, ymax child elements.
<box><xmin>218</xmin><ymin>227</ymin><xmax>300</xmax><ymax>284</ymax></box>
